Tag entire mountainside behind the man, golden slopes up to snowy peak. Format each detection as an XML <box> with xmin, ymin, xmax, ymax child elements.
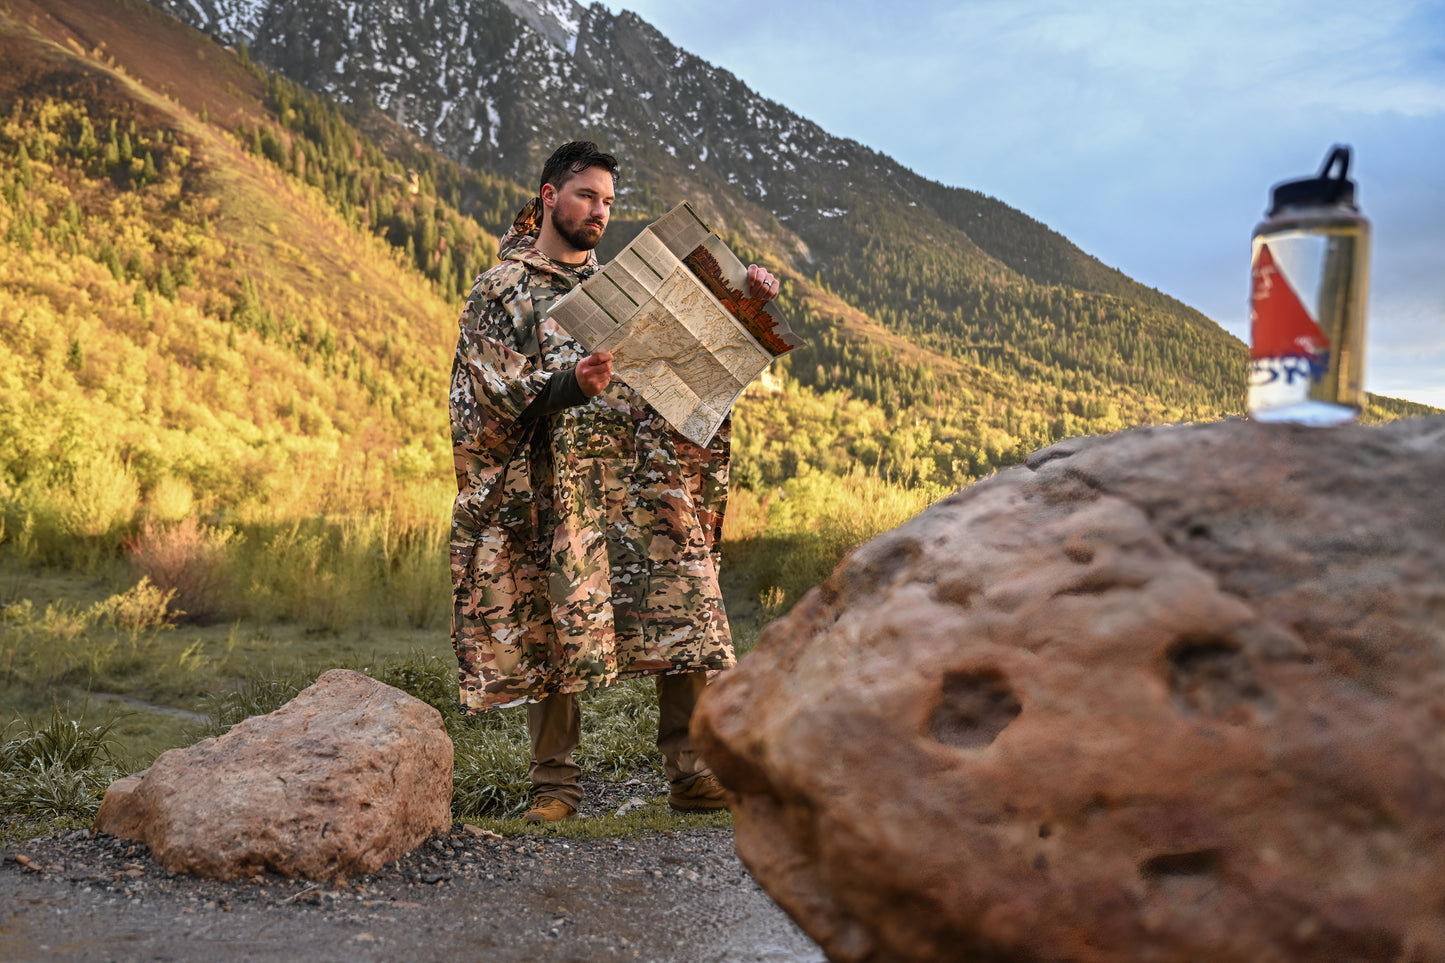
<box><xmin>0</xmin><ymin>0</ymin><xmax>1433</xmax><ymax>540</ymax></box>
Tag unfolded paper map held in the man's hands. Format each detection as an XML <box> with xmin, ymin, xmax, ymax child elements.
<box><xmin>548</xmin><ymin>202</ymin><xmax>802</xmax><ymax>445</ymax></box>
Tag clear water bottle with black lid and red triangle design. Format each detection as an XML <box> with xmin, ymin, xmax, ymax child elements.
<box><xmin>1248</xmin><ymin>145</ymin><xmax>1370</xmax><ymax>425</ymax></box>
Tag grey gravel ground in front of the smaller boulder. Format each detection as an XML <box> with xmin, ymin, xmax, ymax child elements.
<box><xmin>0</xmin><ymin>784</ymin><xmax>825</xmax><ymax>963</ymax></box>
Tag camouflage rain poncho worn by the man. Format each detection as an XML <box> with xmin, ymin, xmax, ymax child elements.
<box><xmin>451</xmin><ymin>201</ymin><xmax>734</xmax><ymax>711</ymax></box>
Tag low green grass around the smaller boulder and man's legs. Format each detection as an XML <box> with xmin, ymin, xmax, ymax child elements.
<box><xmin>0</xmin><ymin>586</ymin><xmax>730</xmax><ymax>842</ymax></box>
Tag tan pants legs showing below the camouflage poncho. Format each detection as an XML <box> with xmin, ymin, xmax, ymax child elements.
<box><xmin>527</xmin><ymin>672</ymin><xmax>711</xmax><ymax>808</ymax></box>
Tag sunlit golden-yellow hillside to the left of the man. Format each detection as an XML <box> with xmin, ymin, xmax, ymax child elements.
<box><xmin>0</xmin><ymin>3</ymin><xmax>473</xmax><ymax>531</ymax></box>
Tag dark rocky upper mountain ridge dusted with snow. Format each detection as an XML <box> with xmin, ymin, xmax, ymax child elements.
<box><xmin>153</xmin><ymin>0</ymin><xmax>1149</xmax><ymax>298</ymax></box>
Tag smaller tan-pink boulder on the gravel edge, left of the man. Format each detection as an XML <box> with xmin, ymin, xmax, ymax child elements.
<box><xmin>95</xmin><ymin>669</ymin><xmax>452</xmax><ymax>879</ymax></box>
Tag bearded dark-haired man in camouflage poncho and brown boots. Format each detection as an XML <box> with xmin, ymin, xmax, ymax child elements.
<box><xmin>451</xmin><ymin>142</ymin><xmax>777</xmax><ymax>823</ymax></box>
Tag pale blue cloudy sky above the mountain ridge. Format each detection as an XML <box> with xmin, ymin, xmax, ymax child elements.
<box><xmin>604</xmin><ymin>0</ymin><xmax>1445</xmax><ymax>408</ymax></box>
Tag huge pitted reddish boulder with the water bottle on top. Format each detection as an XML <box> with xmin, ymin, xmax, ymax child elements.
<box><xmin>694</xmin><ymin>418</ymin><xmax>1445</xmax><ymax>963</ymax></box>
